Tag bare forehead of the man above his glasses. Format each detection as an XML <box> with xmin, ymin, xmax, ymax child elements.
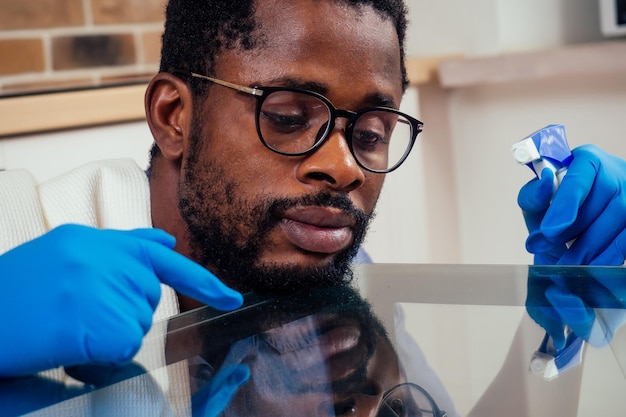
<box><xmin>215</xmin><ymin>0</ymin><xmax>402</xmax><ymax>103</ymax></box>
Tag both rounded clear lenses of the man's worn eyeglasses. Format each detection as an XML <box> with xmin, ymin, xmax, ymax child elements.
<box><xmin>257</xmin><ymin>90</ymin><xmax>413</xmax><ymax>171</ymax></box>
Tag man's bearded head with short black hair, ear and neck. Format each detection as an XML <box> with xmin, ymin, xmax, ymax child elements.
<box><xmin>146</xmin><ymin>2</ymin><xmax>420</xmax><ymax>309</ymax></box>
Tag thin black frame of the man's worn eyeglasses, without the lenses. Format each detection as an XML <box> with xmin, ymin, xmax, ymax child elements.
<box><xmin>172</xmin><ymin>69</ymin><xmax>424</xmax><ymax>174</ymax></box>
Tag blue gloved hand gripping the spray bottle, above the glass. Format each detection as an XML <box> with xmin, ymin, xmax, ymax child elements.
<box><xmin>518</xmin><ymin>145</ymin><xmax>626</xmax><ymax>265</ymax></box>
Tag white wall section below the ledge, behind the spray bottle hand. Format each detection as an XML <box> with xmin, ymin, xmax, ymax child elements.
<box><xmin>450</xmin><ymin>74</ymin><xmax>626</xmax><ymax>263</ymax></box>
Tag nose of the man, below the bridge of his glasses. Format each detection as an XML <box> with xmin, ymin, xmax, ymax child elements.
<box><xmin>297</xmin><ymin>123</ymin><xmax>365</xmax><ymax>192</ymax></box>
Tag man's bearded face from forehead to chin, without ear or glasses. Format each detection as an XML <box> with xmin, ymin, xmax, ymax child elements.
<box><xmin>179</xmin><ymin>0</ymin><xmax>402</xmax><ymax>291</ymax></box>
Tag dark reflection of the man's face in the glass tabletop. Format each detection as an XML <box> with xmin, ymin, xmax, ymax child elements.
<box><xmin>190</xmin><ymin>286</ymin><xmax>441</xmax><ymax>417</ymax></box>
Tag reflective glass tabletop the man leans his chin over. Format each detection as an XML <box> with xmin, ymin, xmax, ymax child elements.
<box><xmin>6</xmin><ymin>264</ymin><xmax>626</xmax><ymax>417</ymax></box>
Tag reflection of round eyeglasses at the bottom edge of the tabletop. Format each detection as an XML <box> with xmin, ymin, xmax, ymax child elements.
<box><xmin>376</xmin><ymin>382</ymin><xmax>446</xmax><ymax>417</ymax></box>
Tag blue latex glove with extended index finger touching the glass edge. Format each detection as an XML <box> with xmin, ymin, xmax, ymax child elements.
<box><xmin>0</xmin><ymin>225</ymin><xmax>243</xmax><ymax>378</ymax></box>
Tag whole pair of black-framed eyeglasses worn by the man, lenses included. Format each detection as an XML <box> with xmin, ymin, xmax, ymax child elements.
<box><xmin>173</xmin><ymin>70</ymin><xmax>423</xmax><ymax>173</ymax></box>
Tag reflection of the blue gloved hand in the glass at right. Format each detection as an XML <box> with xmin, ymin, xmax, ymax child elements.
<box><xmin>526</xmin><ymin>267</ymin><xmax>626</xmax><ymax>349</ymax></box>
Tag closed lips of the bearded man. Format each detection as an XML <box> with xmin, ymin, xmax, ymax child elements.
<box><xmin>279</xmin><ymin>207</ymin><xmax>354</xmax><ymax>254</ymax></box>
